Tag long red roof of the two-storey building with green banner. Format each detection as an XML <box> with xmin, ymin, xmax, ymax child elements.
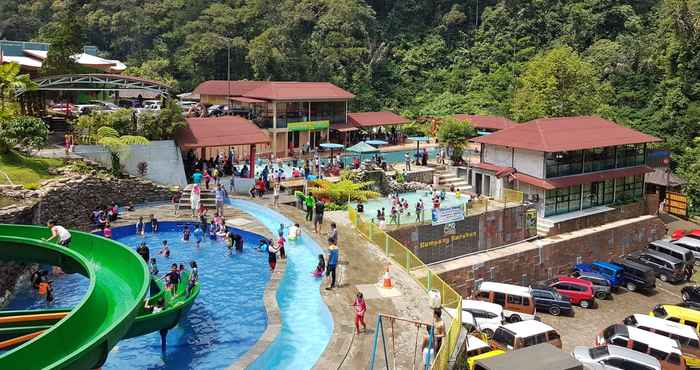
<box><xmin>194</xmin><ymin>80</ymin><xmax>355</xmax><ymax>101</ymax></box>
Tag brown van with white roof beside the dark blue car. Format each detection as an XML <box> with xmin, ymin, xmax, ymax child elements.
<box><xmin>475</xmin><ymin>281</ymin><xmax>535</xmax><ymax>322</ymax></box>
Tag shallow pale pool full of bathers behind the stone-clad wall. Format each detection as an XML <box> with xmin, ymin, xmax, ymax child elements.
<box><xmin>352</xmin><ymin>190</ymin><xmax>469</xmax><ymax>225</ymax></box>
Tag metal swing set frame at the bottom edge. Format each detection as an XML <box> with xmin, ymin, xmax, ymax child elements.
<box><xmin>369</xmin><ymin>313</ymin><xmax>435</xmax><ymax>370</ymax></box>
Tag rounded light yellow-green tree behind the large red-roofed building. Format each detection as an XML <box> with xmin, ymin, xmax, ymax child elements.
<box><xmin>512</xmin><ymin>46</ymin><xmax>605</xmax><ymax>121</ymax></box>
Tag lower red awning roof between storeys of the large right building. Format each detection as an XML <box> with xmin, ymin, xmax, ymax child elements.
<box><xmin>472</xmin><ymin>163</ymin><xmax>653</xmax><ymax>190</ymax></box>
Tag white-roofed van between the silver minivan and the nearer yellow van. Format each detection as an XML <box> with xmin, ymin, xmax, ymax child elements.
<box><xmin>596</xmin><ymin>324</ymin><xmax>686</xmax><ymax>370</ymax></box>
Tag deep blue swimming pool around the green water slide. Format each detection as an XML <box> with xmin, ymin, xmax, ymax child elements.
<box><xmin>8</xmin><ymin>222</ymin><xmax>270</xmax><ymax>370</ymax></box>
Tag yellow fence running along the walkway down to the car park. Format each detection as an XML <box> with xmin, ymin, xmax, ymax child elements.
<box><xmin>348</xmin><ymin>207</ymin><xmax>462</xmax><ymax>370</ymax></box>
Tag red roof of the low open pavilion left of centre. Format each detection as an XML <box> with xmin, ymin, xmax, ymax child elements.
<box><xmin>177</xmin><ymin>116</ymin><xmax>270</xmax><ymax>148</ymax></box>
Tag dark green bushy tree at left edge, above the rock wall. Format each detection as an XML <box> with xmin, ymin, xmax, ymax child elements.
<box><xmin>0</xmin><ymin>116</ymin><xmax>49</xmax><ymax>154</ymax></box>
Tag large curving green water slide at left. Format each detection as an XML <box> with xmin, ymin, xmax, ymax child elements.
<box><xmin>0</xmin><ymin>225</ymin><xmax>199</xmax><ymax>369</ymax></box>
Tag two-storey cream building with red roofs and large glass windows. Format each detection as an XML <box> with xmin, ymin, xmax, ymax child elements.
<box><xmin>469</xmin><ymin>117</ymin><xmax>660</xmax><ymax>218</ymax></box>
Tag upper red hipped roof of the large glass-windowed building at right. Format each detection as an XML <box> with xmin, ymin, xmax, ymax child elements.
<box><xmin>472</xmin><ymin>116</ymin><xmax>661</xmax><ymax>152</ymax></box>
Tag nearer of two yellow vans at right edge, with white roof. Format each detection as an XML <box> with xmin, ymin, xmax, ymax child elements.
<box><xmin>624</xmin><ymin>314</ymin><xmax>700</xmax><ymax>368</ymax></box>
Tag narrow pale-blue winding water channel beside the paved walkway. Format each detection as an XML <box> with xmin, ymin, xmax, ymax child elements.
<box><xmin>230</xmin><ymin>199</ymin><xmax>333</xmax><ymax>370</ymax></box>
